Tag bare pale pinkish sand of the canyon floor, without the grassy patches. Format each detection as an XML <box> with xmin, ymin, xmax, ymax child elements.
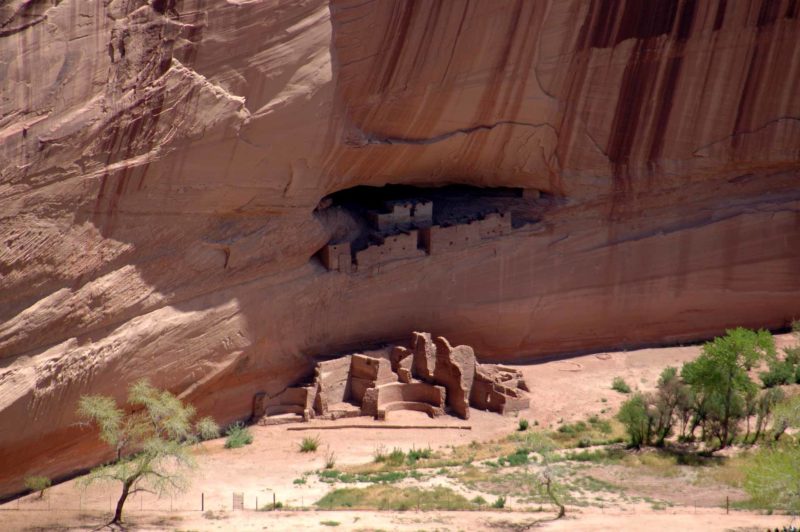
<box><xmin>0</xmin><ymin>335</ymin><xmax>791</xmax><ymax>530</ymax></box>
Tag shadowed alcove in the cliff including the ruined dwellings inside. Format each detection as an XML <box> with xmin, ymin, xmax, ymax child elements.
<box><xmin>317</xmin><ymin>185</ymin><xmax>552</xmax><ymax>273</ymax></box>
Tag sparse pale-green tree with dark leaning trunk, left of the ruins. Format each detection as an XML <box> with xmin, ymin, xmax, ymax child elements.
<box><xmin>78</xmin><ymin>379</ymin><xmax>219</xmax><ymax>524</ymax></box>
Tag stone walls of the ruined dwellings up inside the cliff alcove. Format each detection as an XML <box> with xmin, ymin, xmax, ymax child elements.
<box><xmin>319</xmin><ymin>196</ymin><xmax>512</xmax><ymax>273</ymax></box>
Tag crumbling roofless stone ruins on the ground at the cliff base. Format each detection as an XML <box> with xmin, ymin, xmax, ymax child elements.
<box><xmin>253</xmin><ymin>332</ymin><xmax>530</xmax><ymax>425</ymax></box>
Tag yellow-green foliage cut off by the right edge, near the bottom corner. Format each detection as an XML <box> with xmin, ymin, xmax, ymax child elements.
<box><xmin>744</xmin><ymin>445</ymin><xmax>800</xmax><ymax>514</ymax></box>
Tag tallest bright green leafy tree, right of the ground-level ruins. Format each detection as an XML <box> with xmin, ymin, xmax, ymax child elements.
<box><xmin>681</xmin><ymin>327</ymin><xmax>775</xmax><ymax>450</ymax></box>
